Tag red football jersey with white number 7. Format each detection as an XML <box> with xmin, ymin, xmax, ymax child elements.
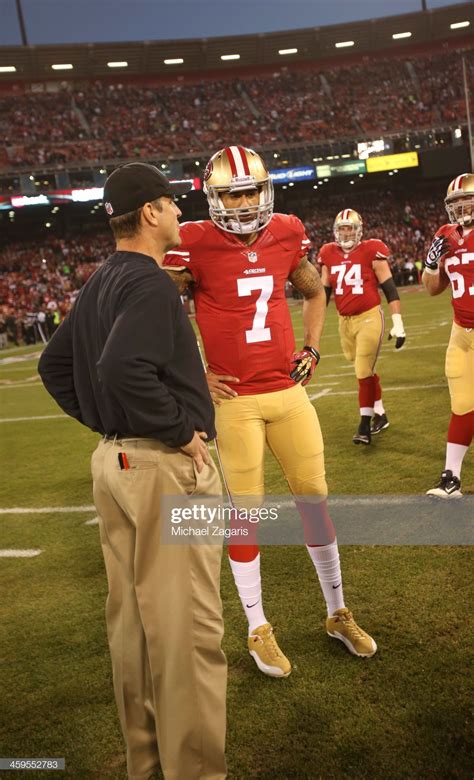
<box><xmin>164</xmin><ymin>214</ymin><xmax>311</xmax><ymax>395</ymax></box>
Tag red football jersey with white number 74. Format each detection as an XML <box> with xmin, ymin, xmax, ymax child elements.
<box><xmin>318</xmin><ymin>238</ymin><xmax>390</xmax><ymax>316</ymax></box>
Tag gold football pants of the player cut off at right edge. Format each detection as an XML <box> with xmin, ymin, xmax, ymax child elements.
<box><xmin>445</xmin><ymin>322</ymin><xmax>474</xmax><ymax>415</ymax></box>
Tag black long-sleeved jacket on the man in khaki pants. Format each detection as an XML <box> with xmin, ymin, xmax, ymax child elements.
<box><xmin>38</xmin><ymin>252</ymin><xmax>215</xmax><ymax>447</ymax></box>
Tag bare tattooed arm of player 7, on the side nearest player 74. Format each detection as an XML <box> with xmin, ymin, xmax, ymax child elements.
<box><xmin>289</xmin><ymin>256</ymin><xmax>326</xmax><ymax>351</ymax></box>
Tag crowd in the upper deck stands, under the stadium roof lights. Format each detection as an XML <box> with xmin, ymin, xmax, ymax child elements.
<box><xmin>0</xmin><ymin>49</ymin><xmax>474</xmax><ymax>169</ymax></box>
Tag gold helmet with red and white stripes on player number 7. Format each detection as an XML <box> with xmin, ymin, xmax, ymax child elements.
<box><xmin>204</xmin><ymin>146</ymin><xmax>274</xmax><ymax>233</ymax></box>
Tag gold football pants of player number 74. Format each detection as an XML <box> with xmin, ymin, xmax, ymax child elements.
<box><xmin>339</xmin><ymin>306</ymin><xmax>384</xmax><ymax>379</ymax></box>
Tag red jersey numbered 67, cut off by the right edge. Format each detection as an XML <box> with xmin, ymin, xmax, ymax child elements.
<box><xmin>435</xmin><ymin>225</ymin><xmax>474</xmax><ymax>328</ymax></box>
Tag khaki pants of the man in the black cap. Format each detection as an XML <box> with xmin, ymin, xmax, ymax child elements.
<box><xmin>92</xmin><ymin>439</ymin><xmax>227</xmax><ymax>780</ymax></box>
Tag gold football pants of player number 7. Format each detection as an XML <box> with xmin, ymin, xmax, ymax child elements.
<box><xmin>216</xmin><ymin>384</ymin><xmax>327</xmax><ymax>496</ymax></box>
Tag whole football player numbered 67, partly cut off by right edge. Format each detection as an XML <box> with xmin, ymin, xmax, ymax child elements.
<box><xmin>423</xmin><ymin>173</ymin><xmax>474</xmax><ymax>498</ymax></box>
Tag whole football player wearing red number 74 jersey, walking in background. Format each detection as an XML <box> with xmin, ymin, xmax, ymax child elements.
<box><xmin>318</xmin><ymin>209</ymin><xmax>405</xmax><ymax>444</ymax></box>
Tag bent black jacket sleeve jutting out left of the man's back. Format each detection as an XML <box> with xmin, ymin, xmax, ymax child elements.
<box><xmin>38</xmin><ymin>315</ymin><xmax>82</xmax><ymax>423</ymax></box>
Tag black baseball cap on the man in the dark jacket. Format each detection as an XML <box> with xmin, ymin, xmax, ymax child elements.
<box><xmin>104</xmin><ymin>162</ymin><xmax>193</xmax><ymax>217</ymax></box>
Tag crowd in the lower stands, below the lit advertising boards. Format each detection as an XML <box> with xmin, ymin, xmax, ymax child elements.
<box><xmin>0</xmin><ymin>186</ymin><xmax>446</xmax><ymax>343</ymax></box>
